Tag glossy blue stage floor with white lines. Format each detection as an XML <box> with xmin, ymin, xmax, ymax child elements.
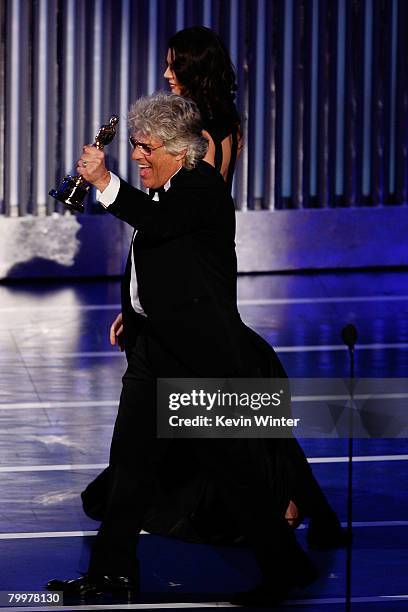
<box><xmin>0</xmin><ymin>271</ymin><xmax>408</xmax><ymax>612</ymax></box>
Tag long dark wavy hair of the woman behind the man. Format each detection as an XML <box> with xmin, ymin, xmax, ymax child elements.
<box><xmin>168</xmin><ymin>26</ymin><xmax>240</xmax><ymax>126</ymax></box>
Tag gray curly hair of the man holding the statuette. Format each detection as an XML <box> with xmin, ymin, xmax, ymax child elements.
<box><xmin>128</xmin><ymin>91</ymin><xmax>208</xmax><ymax>170</ymax></box>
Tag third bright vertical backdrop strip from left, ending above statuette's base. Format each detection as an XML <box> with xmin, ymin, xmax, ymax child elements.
<box><xmin>62</xmin><ymin>0</ymin><xmax>78</xmax><ymax>174</ymax></box>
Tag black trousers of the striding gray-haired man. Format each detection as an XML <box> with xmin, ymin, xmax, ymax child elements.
<box><xmin>89</xmin><ymin>332</ymin><xmax>302</xmax><ymax>579</ymax></box>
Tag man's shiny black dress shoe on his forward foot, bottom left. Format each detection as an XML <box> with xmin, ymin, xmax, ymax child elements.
<box><xmin>45</xmin><ymin>574</ymin><xmax>139</xmax><ymax>597</ymax></box>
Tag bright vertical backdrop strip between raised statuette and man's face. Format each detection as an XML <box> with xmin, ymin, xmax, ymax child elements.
<box><xmin>118</xmin><ymin>0</ymin><xmax>131</xmax><ymax>176</ymax></box>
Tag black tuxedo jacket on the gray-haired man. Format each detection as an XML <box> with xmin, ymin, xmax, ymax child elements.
<box><xmin>108</xmin><ymin>162</ymin><xmax>284</xmax><ymax>377</ymax></box>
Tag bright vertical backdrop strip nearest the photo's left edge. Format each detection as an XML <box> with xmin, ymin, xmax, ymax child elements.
<box><xmin>8</xmin><ymin>0</ymin><xmax>21</xmax><ymax>217</ymax></box>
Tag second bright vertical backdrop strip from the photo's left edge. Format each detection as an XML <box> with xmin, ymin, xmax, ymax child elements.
<box><xmin>34</xmin><ymin>0</ymin><xmax>49</xmax><ymax>215</ymax></box>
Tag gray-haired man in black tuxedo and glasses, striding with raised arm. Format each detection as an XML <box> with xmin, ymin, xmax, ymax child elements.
<box><xmin>48</xmin><ymin>94</ymin><xmax>316</xmax><ymax>605</ymax></box>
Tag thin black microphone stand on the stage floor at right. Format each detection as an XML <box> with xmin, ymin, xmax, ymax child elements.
<box><xmin>341</xmin><ymin>323</ymin><xmax>357</xmax><ymax>612</ymax></box>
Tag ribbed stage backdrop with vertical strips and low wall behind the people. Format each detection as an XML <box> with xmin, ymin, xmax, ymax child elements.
<box><xmin>0</xmin><ymin>0</ymin><xmax>408</xmax><ymax>278</ymax></box>
